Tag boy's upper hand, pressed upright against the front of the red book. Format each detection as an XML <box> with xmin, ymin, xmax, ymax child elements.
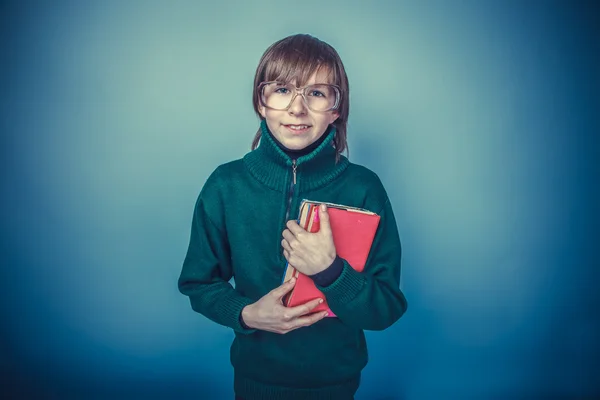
<box><xmin>281</xmin><ymin>205</ymin><xmax>336</xmax><ymax>275</ymax></box>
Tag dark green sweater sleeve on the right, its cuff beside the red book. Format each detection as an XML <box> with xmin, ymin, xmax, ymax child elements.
<box><xmin>316</xmin><ymin>199</ymin><xmax>407</xmax><ymax>330</ymax></box>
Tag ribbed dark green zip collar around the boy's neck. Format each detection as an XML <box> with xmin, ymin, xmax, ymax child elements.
<box><xmin>244</xmin><ymin>120</ymin><xmax>349</xmax><ymax>192</ymax></box>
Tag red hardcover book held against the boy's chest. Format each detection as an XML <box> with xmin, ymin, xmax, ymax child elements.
<box><xmin>283</xmin><ymin>200</ymin><xmax>380</xmax><ymax>317</ymax></box>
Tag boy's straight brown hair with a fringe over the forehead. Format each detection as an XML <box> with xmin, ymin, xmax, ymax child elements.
<box><xmin>252</xmin><ymin>34</ymin><xmax>350</xmax><ymax>160</ymax></box>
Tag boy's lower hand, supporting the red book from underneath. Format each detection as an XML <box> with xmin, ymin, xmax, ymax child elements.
<box><xmin>242</xmin><ymin>278</ymin><xmax>327</xmax><ymax>334</ymax></box>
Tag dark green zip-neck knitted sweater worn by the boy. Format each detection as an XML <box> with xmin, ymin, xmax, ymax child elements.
<box><xmin>178</xmin><ymin>121</ymin><xmax>407</xmax><ymax>400</ymax></box>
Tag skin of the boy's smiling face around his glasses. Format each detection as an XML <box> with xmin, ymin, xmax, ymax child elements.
<box><xmin>259</xmin><ymin>70</ymin><xmax>339</xmax><ymax>150</ymax></box>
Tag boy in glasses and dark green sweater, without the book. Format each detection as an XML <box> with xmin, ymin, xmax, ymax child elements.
<box><xmin>179</xmin><ymin>35</ymin><xmax>407</xmax><ymax>400</ymax></box>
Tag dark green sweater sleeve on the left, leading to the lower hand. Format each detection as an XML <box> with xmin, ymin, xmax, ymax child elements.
<box><xmin>178</xmin><ymin>188</ymin><xmax>255</xmax><ymax>334</ymax></box>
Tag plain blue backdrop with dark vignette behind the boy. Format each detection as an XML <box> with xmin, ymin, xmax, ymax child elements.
<box><xmin>0</xmin><ymin>0</ymin><xmax>600</xmax><ymax>400</ymax></box>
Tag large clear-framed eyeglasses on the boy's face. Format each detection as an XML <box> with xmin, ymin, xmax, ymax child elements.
<box><xmin>258</xmin><ymin>81</ymin><xmax>340</xmax><ymax>112</ymax></box>
